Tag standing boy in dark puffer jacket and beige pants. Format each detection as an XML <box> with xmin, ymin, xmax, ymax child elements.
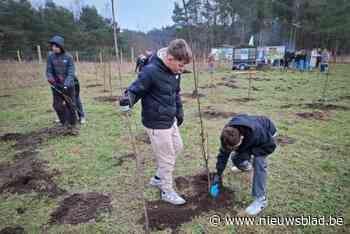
<box><xmin>120</xmin><ymin>39</ymin><xmax>192</xmax><ymax>205</ymax></box>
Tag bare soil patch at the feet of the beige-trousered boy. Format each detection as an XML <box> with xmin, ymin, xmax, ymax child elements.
<box><xmin>139</xmin><ymin>174</ymin><xmax>235</xmax><ymax>232</ymax></box>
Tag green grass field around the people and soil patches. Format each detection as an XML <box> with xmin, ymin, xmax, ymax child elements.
<box><xmin>0</xmin><ymin>64</ymin><xmax>350</xmax><ymax>234</ymax></box>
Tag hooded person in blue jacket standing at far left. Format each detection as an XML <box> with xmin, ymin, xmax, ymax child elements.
<box><xmin>46</xmin><ymin>36</ymin><xmax>79</xmax><ymax>133</ymax></box>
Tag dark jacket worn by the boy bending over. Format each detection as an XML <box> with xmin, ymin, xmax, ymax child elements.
<box><xmin>216</xmin><ymin>114</ymin><xmax>277</xmax><ymax>175</ymax></box>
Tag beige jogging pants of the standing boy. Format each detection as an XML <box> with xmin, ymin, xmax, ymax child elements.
<box><xmin>146</xmin><ymin>121</ymin><xmax>183</xmax><ymax>192</ymax></box>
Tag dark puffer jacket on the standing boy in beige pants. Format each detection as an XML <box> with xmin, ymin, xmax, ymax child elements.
<box><xmin>127</xmin><ymin>55</ymin><xmax>183</xmax><ymax>129</ymax></box>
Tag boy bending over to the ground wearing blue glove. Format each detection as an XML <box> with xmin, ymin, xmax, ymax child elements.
<box><xmin>213</xmin><ymin>114</ymin><xmax>277</xmax><ymax>215</ymax></box>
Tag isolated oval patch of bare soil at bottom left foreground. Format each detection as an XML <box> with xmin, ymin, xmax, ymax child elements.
<box><xmin>50</xmin><ymin>192</ymin><xmax>112</xmax><ymax>224</ymax></box>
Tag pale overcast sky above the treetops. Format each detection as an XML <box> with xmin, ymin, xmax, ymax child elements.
<box><xmin>31</xmin><ymin>0</ymin><xmax>179</xmax><ymax>32</ymax></box>
